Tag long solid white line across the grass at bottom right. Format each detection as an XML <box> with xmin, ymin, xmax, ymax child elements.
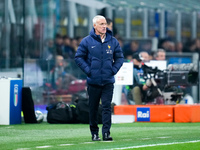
<box><xmin>107</xmin><ymin>140</ymin><xmax>200</xmax><ymax>150</ymax></box>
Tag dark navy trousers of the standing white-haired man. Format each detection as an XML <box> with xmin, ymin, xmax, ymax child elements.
<box><xmin>87</xmin><ymin>84</ymin><xmax>114</xmax><ymax>135</ymax></box>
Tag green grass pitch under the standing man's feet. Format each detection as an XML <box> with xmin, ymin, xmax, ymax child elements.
<box><xmin>0</xmin><ymin>122</ymin><xmax>200</xmax><ymax>150</ymax></box>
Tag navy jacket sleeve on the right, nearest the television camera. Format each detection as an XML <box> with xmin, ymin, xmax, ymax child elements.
<box><xmin>112</xmin><ymin>40</ymin><xmax>124</xmax><ymax>75</ymax></box>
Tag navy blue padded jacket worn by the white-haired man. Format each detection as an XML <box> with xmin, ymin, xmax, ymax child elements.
<box><xmin>75</xmin><ymin>28</ymin><xmax>124</xmax><ymax>86</ymax></box>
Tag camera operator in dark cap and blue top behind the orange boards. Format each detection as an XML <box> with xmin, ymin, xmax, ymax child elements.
<box><xmin>131</xmin><ymin>53</ymin><xmax>151</xmax><ymax>105</ymax></box>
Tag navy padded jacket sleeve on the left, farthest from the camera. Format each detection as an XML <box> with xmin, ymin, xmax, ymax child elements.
<box><xmin>75</xmin><ymin>40</ymin><xmax>90</xmax><ymax>75</ymax></box>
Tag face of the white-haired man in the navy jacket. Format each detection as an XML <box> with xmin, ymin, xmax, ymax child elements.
<box><xmin>94</xmin><ymin>18</ymin><xmax>107</xmax><ymax>35</ymax></box>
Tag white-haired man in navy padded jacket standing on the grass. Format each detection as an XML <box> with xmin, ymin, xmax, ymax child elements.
<box><xmin>75</xmin><ymin>15</ymin><xmax>124</xmax><ymax>141</ymax></box>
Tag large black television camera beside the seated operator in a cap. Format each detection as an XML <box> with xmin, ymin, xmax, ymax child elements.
<box><xmin>142</xmin><ymin>64</ymin><xmax>198</xmax><ymax>103</ymax></box>
